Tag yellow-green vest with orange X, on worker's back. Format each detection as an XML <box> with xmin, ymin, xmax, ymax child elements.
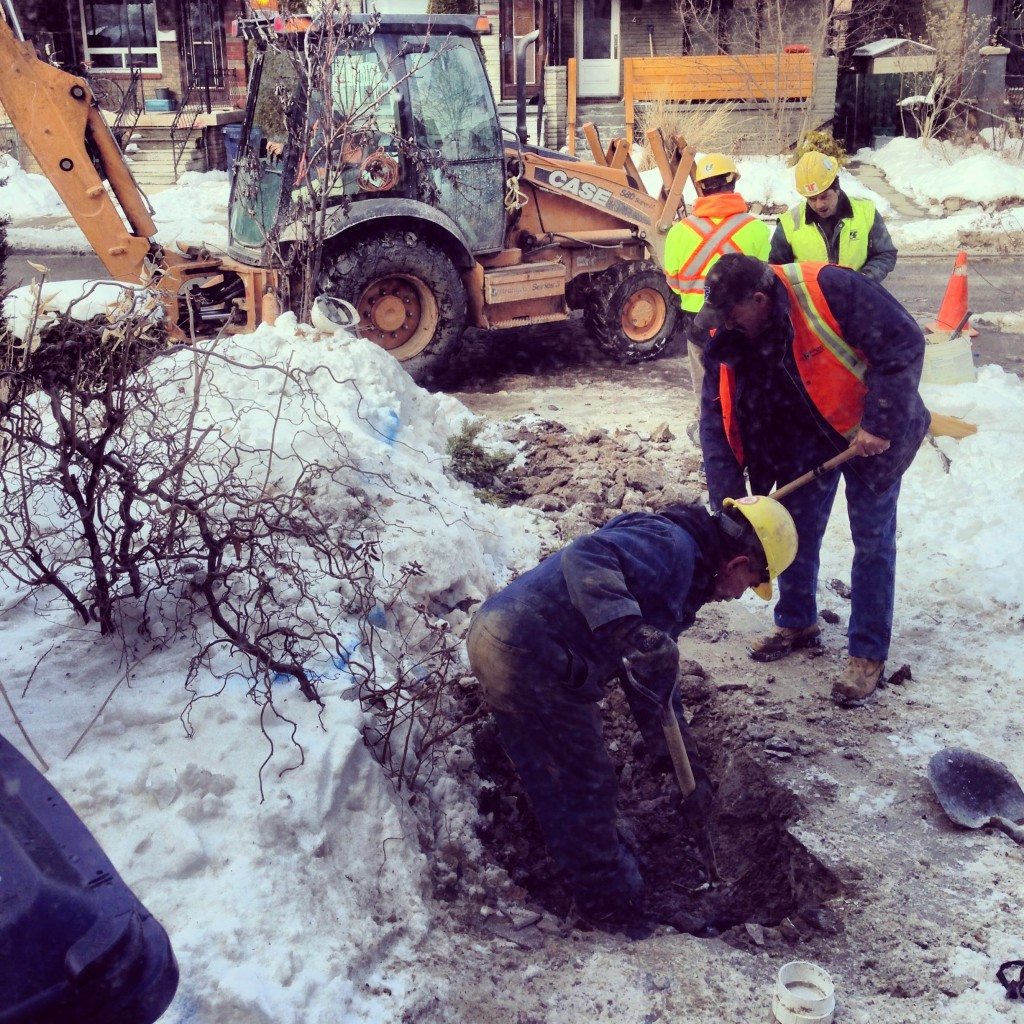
<box><xmin>665</xmin><ymin>193</ymin><xmax>771</xmax><ymax>313</ymax></box>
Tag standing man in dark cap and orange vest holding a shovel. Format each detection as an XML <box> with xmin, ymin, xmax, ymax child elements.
<box><xmin>697</xmin><ymin>254</ymin><xmax>929</xmax><ymax>706</ymax></box>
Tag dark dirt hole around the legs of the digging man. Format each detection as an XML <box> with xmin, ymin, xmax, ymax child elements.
<box><xmin>474</xmin><ymin>686</ymin><xmax>841</xmax><ymax>942</ymax></box>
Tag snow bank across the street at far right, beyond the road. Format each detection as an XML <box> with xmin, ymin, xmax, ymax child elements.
<box><xmin>857</xmin><ymin>138</ymin><xmax>1024</xmax><ymax>213</ymax></box>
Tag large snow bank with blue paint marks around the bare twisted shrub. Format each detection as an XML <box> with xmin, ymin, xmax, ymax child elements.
<box><xmin>0</xmin><ymin>316</ymin><xmax>539</xmax><ymax>1024</ymax></box>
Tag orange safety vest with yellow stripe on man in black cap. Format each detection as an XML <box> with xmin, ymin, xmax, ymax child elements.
<box><xmin>719</xmin><ymin>263</ymin><xmax>867</xmax><ymax>466</ymax></box>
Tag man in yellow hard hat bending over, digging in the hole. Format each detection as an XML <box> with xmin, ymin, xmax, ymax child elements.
<box><xmin>466</xmin><ymin>497</ymin><xmax>797</xmax><ymax>937</ymax></box>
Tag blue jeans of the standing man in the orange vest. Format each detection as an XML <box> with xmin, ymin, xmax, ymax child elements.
<box><xmin>775</xmin><ymin>466</ymin><xmax>900</xmax><ymax>662</ymax></box>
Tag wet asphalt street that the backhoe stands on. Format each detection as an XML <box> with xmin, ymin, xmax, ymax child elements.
<box><xmin>7</xmin><ymin>252</ymin><xmax>1024</xmax><ymax>391</ymax></box>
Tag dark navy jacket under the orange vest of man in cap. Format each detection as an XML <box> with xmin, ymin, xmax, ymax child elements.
<box><xmin>700</xmin><ymin>260</ymin><xmax>929</xmax><ymax>509</ymax></box>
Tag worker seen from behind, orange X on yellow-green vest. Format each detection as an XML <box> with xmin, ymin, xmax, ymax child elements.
<box><xmin>665</xmin><ymin>153</ymin><xmax>771</xmax><ymax>419</ymax></box>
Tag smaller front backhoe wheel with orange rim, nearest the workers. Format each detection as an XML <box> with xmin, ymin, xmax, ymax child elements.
<box><xmin>584</xmin><ymin>259</ymin><xmax>680</xmax><ymax>362</ymax></box>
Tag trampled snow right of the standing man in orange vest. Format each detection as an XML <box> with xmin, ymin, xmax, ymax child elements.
<box><xmin>821</xmin><ymin>366</ymin><xmax>1024</xmax><ymax>678</ymax></box>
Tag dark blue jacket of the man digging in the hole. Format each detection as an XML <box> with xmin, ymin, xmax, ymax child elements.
<box><xmin>476</xmin><ymin>509</ymin><xmax>720</xmax><ymax>683</ymax></box>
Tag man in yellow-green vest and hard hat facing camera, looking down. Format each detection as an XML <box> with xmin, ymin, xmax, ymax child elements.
<box><xmin>768</xmin><ymin>150</ymin><xmax>896</xmax><ymax>282</ymax></box>
